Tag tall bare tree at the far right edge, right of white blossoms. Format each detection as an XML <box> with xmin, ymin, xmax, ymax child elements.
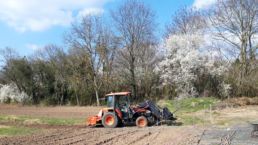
<box><xmin>210</xmin><ymin>0</ymin><xmax>258</xmax><ymax>95</ymax></box>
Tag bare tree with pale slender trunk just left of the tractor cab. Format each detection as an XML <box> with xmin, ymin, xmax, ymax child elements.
<box><xmin>66</xmin><ymin>15</ymin><xmax>114</xmax><ymax>105</ymax></box>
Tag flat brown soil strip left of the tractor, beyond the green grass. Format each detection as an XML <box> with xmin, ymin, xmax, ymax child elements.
<box><xmin>0</xmin><ymin>104</ymin><xmax>100</xmax><ymax>118</ymax></box>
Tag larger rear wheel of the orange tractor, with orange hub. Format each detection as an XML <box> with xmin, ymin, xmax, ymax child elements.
<box><xmin>101</xmin><ymin>112</ymin><xmax>118</xmax><ymax>128</ymax></box>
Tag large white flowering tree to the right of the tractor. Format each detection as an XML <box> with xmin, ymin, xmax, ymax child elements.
<box><xmin>158</xmin><ymin>34</ymin><xmax>229</xmax><ymax>97</ymax></box>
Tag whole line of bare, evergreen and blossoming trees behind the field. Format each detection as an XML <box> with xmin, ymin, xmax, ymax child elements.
<box><xmin>0</xmin><ymin>0</ymin><xmax>258</xmax><ymax>105</ymax></box>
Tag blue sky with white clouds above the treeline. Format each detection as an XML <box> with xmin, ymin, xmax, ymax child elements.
<box><xmin>0</xmin><ymin>0</ymin><xmax>215</xmax><ymax>56</ymax></box>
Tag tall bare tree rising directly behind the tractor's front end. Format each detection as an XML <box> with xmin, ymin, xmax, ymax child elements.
<box><xmin>112</xmin><ymin>0</ymin><xmax>156</xmax><ymax>97</ymax></box>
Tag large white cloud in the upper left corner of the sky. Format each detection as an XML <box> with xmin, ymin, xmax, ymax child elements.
<box><xmin>0</xmin><ymin>0</ymin><xmax>111</xmax><ymax>32</ymax></box>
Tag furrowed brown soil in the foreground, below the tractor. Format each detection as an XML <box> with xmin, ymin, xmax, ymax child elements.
<box><xmin>0</xmin><ymin>126</ymin><xmax>201</xmax><ymax>145</ymax></box>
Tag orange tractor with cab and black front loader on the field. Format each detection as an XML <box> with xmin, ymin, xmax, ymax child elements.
<box><xmin>87</xmin><ymin>92</ymin><xmax>176</xmax><ymax>128</ymax></box>
